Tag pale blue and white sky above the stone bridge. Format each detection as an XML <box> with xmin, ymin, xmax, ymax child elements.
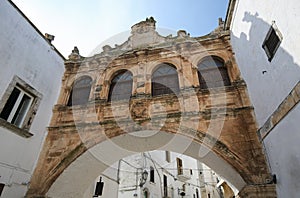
<box><xmin>12</xmin><ymin>0</ymin><xmax>228</xmax><ymax>58</ymax></box>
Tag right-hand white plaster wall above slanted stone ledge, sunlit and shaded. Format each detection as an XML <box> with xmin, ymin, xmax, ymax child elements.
<box><xmin>231</xmin><ymin>0</ymin><xmax>300</xmax><ymax>126</ymax></box>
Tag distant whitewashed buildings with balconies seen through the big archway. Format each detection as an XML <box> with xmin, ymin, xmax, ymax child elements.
<box><xmin>84</xmin><ymin>151</ymin><xmax>232</xmax><ymax>198</ymax></box>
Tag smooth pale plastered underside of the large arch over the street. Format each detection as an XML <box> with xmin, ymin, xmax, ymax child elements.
<box><xmin>47</xmin><ymin>131</ymin><xmax>245</xmax><ymax>198</ymax></box>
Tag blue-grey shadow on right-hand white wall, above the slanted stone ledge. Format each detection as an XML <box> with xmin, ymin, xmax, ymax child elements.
<box><xmin>231</xmin><ymin>12</ymin><xmax>300</xmax><ymax>126</ymax></box>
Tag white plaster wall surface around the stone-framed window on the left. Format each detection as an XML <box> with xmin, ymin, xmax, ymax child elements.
<box><xmin>0</xmin><ymin>0</ymin><xmax>64</xmax><ymax>197</ymax></box>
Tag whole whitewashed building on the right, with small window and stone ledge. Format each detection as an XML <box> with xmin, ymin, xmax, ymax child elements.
<box><xmin>226</xmin><ymin>0</ymin><xmax>300</xmax><ymax>197</ymax></box>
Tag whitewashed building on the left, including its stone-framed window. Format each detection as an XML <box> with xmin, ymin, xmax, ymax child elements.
<box><xmin>0</xmin><ymin>0</ymin><xmax>64</xmax><ymax>198</ymax></box>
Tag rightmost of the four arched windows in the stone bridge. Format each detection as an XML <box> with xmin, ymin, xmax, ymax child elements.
<box><xmin>198</xmin><ymin>57</ymin><xmax>230</xmax><ymax>89</ymax></box>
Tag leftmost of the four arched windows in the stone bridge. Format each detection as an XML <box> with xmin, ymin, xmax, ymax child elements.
<box><xmin>67</xmin><ymin>76</ymin><xmax>92</xmax><ymax>106</ymax></box>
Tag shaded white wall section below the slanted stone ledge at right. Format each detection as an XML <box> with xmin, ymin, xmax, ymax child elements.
<box><xmin>264</xmin><ymin>104</ymin><xmax>300</xmax><ymax>198</ymax></box>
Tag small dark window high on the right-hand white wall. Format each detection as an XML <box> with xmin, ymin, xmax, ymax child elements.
<box><xmin>262</xmin><ymin>22</ymin><xmax>282</xmax><ymax>62</ymax></box>
